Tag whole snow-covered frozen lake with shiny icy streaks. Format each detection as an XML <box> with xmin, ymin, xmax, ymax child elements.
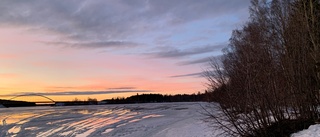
<box><xmin>0</xmin><ymin>102</ymin><xmax>215</xmax><ymax>137</ymax></box>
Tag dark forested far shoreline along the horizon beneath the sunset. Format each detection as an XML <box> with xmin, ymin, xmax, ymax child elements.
<box><xmin>0</xmin><ymin>91</ymin><xmax>212</xmax><ymax>107</ymax></box>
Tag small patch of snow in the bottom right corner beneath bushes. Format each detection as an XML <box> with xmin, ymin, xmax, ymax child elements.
<box><xmin>291</xmin><ymin>124</ymin><xmax>320</xmax><ymax>137</ymax></box>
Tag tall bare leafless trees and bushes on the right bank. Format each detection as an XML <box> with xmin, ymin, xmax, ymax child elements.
<box><xmin>205</xmin><ymin>0</ymin><xmax>320</xmax><ymax>137</ymax></box>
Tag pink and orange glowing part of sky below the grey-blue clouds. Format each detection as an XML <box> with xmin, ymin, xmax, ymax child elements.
<box><xmin>0</xmin><ymin>26</ymin><xmax>204</xmax><ymax>101</ymax></box>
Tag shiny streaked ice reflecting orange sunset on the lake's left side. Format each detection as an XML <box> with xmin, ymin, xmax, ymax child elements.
<box><xmin>0</xmin><ymin>106</ymin><xmax>168</xmax><ymax>137</ymax></box>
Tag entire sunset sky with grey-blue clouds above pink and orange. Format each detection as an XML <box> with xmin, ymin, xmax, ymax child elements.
<box><xmin>0</xmin><ymin>0</ymin><xmax>250</xmax><ymax>100</ymax></box>
